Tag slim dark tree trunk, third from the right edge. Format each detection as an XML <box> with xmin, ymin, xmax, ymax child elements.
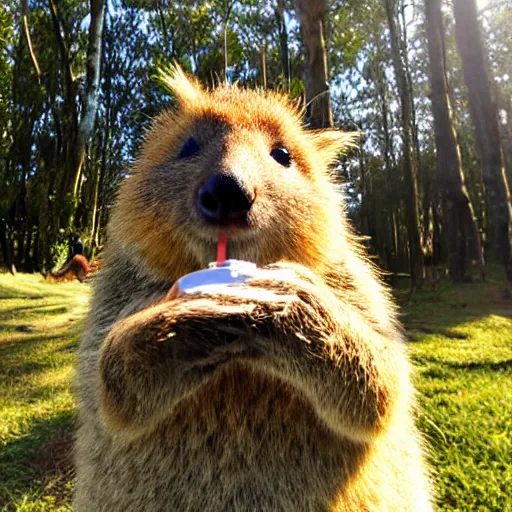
<box><xmin>384</xmin><ymin>0</ymin><xmax>423</xmax><ymax>289</ymax></box>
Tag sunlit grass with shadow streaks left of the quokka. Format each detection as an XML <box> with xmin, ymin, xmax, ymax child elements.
<box><xmin>0</xmin><ymin>274</ymin><xmax>89</xmax><ymax>511</ymax></box>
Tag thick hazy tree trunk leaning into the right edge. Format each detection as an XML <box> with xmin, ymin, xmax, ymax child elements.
<box><xmin>453</xmin><ymin>0</ymin><xmax>512</xmax><ymax>280</ymax></box>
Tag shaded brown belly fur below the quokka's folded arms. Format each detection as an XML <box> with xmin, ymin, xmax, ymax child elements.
<box><xmin>75</xmin><ymin>366</ymin><xmax>368</xmax><ymax>511</ymax></box>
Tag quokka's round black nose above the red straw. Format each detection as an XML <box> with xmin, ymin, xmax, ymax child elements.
<box><xmin>196</xmin><ymin>174</ymin><xmax>252</xmax><ymax>225</ymax></box>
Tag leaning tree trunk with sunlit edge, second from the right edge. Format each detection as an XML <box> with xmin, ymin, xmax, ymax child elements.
<box><xmin>425</xmin><ymin>0</ymin><xmax>483</xmax><ymax>282</ymax></box>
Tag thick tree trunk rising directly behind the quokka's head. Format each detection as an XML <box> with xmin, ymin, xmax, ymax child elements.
<box><xmin>295</xmin><ymin>0</ymin><xmax>334</xmax><ymax>128</ymax></box>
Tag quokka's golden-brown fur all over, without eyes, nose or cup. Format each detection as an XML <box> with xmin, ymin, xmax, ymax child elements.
<box><xmin>74</xmin><ymin>69</ymin><xmax>431</xmax><ymax>512</ymax></box>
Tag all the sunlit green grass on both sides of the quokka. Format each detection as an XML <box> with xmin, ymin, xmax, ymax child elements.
<box><xmin>0</xmin><ymin>274</ymin><xmax>512</xmax><ymax>512</ymax></box>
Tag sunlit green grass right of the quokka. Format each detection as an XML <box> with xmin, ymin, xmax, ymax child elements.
<box><xmin>403</xmin><ymin>270</ymin><xmax>512</xmax><ymax>512</ymax></box>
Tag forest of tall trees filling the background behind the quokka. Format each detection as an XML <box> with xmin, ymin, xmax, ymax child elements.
<box><xmin>0</xmin><ymin>0</ymin><xmax>512</xmax><ymax>286</ymax></box>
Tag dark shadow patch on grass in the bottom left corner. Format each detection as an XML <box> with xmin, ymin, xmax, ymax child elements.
<box><xmin>0</xmin><ymin>412</ymin><xmax>75</xmax><ymax>510</ymax></box>
